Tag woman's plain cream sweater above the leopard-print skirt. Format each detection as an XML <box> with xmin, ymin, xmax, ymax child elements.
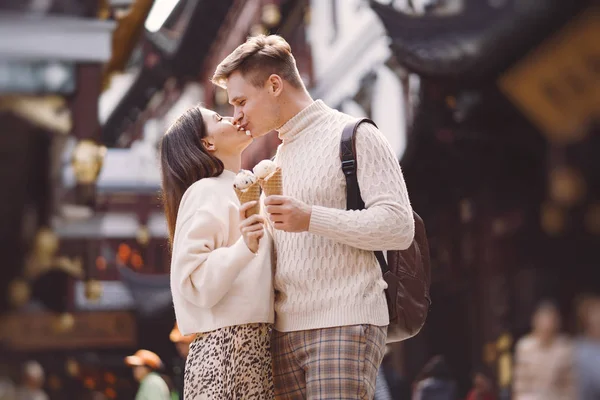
<box><xmin>171</xmin><ymin>170</ymin><xmax>273</xmax><ymax>335</ymax></box>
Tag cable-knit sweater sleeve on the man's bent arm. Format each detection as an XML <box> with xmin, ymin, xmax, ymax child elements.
<box><xmin>309</xmin><ymin>124</ymin><xmax>415</xmax><ymax>250</ymax></box>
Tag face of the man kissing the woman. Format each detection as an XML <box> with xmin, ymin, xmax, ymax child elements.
<box><xmin>227</xmin><ymin>71</ymin><xmax>280</xmax><ymax>137</ymax></box>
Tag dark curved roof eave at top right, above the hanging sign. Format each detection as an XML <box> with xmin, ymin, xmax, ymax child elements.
<box><xmin>371</xmin><ymin>0</ymin><xmax>587</xmax><ymax>80</ymax></box>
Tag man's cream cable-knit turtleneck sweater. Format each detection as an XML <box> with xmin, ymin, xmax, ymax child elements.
<box><xmin>273</xmin><ymin>100</ymin><xmax>414</xmax><ymax>332</ymax></box>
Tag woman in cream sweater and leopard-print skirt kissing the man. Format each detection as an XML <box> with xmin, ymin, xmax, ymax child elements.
<box><xmin>160</xmin><ymin>107</ymin><xmax>273</xmax><ymax>399</ymax></box>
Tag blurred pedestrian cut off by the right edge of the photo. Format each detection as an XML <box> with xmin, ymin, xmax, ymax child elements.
<box><xmin>575</xmin><ymin>296</ymin><xmax>600</xmax><ymax>400</ymax></box>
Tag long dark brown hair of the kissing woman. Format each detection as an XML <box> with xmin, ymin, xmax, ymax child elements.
<box><xmin>160</xmin><ymin>106</ymin><xmax>224</xmax><ymax>246</ymax></box>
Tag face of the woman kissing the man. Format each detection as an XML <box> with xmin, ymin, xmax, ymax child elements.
<box><xmin>202</xmin><ymin>108</ymin><xmax>252</xmax><ymax>158</ymax></box>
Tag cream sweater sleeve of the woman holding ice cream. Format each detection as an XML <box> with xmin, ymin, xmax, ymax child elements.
<box><xmin>171</xmin><ymin>194</ymin><xmax>255</xmax><ymax>308</ymax></box>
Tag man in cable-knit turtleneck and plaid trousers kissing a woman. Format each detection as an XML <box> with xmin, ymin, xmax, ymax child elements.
<box><xmin>212</xmin><ymin>35</ymin><xmax>414</xmax><ymax>399</ymax></box>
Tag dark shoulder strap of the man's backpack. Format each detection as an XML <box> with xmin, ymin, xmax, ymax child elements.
<box><xmin>340</xmin><ymin>118</ymin><xmax>389</xmax><ymax>274</ymax></box>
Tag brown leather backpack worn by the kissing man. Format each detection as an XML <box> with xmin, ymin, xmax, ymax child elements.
<box><xmin>340</xmin><ymin>118</ymin><xmax>431</xmax><ymax>343</ymax></box>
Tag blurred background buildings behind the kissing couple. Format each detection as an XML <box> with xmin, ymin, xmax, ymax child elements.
<box><xmin>0</xmin><ymin>0</ymin><xmax>600</xmax><ymax>399</ymax></box>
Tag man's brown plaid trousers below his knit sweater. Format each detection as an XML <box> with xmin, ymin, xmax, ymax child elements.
<box><xmin>271</xmin><ymin>325</ymin><xmax>387</xmax><ymax>400</ymax></box>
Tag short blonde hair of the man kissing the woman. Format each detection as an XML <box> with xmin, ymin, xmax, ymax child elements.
<box><xmin>211</xmin><ymin>35</ymin><xmax>303</xmax><ymax>89</ymax></box>
